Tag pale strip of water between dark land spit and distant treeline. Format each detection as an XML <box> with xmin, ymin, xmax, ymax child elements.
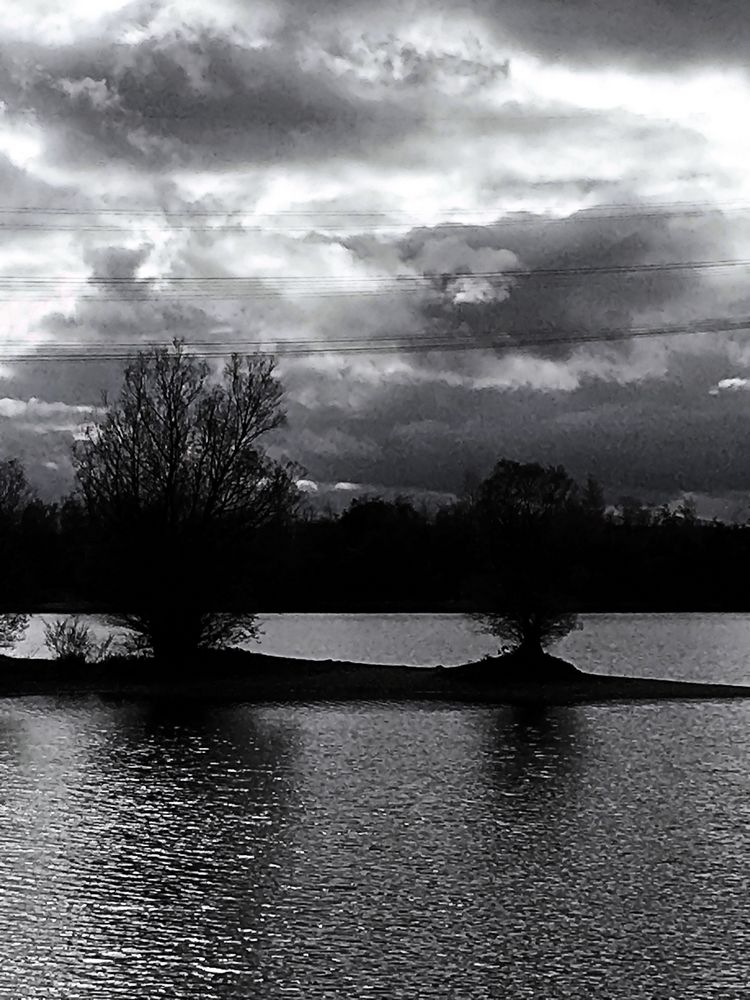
<box><xmin>7</xmin><ymin>614</ymin><xmax>750</xmax><ymax>684</ymax></box>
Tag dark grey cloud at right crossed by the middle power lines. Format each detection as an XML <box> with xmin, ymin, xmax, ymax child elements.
<box><xmin>338</xmin><ymin>204</ymin><xmax>750</xmax><ymax>372</ymax></box>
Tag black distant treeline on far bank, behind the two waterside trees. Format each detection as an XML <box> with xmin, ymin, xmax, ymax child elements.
<box><xmin>0</xmin><ymin>460</ymin><xmax>750</xmax><ymax>612</ymax></box>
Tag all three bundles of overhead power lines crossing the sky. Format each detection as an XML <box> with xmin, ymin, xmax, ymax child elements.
<box><xmin>0</xmin><ymin>202</ymin><xmax>750</xmax><ymax>362</ymax></box>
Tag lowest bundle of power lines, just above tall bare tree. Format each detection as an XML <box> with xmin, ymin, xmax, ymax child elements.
<box><xmin>0</xmin><ymin>316</ymin><xmax>750</xmax><ymax>363</ymax></box>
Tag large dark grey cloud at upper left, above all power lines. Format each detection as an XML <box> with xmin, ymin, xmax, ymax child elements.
<box><xmin>2</xmin><ymin>29</ymin><xmax>434</xmax><ymax>169</ymax></box>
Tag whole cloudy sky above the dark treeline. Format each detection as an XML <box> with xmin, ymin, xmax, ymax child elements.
<box><xmin>0</xmin><ymin>0</ymin><xmax>750</xmax><ymax>509</ymax></box>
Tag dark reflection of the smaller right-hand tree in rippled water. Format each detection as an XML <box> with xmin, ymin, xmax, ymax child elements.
<box><xmin>472</xmin><ymin>706</ymin><xmax>588</xmax><ymax>997</ymax></box>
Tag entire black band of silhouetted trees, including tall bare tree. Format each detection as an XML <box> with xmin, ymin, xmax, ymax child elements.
<box><xmin>0</xmin><ymin>343</ymin><xmax>750</xmax><ymax>659</ymax></box>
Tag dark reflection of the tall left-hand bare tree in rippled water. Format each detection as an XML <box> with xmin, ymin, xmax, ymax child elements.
<box><xmin>55</xmin><ymin>705</ymin><xmax>306</xmax><ymax>998</ymax></box>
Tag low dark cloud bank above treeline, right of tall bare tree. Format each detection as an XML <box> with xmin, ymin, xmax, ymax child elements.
<box><xmin>290</xmin><ymin>343</ymin><xmax>750</xmax><ymax>499</ymax></box>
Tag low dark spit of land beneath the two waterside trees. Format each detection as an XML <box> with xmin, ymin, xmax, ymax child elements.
<box><xmin>0</xmin><ymin>650</ymin><xmax>750</xmax><ymax>705</ymax></box>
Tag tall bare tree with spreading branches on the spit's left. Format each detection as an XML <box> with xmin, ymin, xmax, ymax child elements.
<box><xmin>74</xmin><ymin>341</ymin><xmax>297</xmax><ymax>657</ymax></box>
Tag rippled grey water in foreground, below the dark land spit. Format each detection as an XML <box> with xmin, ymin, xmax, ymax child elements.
<box><xmin>0</xmin><ymin>699</ymin><xmax>750</xmax><ymax>1000</ymax></box>
